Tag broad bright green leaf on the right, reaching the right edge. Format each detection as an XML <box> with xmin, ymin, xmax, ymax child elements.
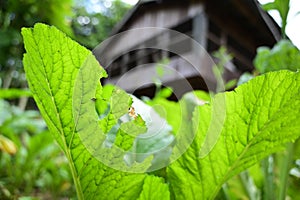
<box><xmin>167</xmin><ymin>71</ymin><xmax>300</xmax><ymax>199</ymax></box>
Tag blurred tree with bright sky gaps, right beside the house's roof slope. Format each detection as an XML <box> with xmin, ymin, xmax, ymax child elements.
<box><xmin>72</xmin><ymin>0</ymin><xmax>131</xmax><ymax>49</ymax></box>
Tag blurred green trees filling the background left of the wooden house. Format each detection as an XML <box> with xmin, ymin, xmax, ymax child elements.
<box><xmin>0</xmin><ymin>0</ymin><xmax>130</xmax><ymax>88</ymax></box>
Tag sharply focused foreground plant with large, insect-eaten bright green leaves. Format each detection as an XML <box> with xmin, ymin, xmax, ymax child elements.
<box><xmin>22</xmin><ymin>24</ymin><xmax>300</xmax><ymax>199</ymax></box>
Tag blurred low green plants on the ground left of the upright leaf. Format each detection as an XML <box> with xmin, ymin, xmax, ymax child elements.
<box><xmin>0</xmin><ymin>95</ymin><xmax>74</xmax><ymax>199</ymax></box>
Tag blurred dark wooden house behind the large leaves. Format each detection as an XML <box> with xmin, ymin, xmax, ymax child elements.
<box><xmin>94</xmin><ymin>0</ymin><xmax>280</xmax><ymax>96</ymax></box>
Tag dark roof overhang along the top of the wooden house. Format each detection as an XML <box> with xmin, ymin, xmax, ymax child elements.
<box><xmin>111</xmin><ymin>0</ymin><xmax>281</xmax><ymax>45</ymax></box>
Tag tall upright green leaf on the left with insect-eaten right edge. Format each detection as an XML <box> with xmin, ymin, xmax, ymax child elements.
<box><xmin>22</xmin><ymin>24</ymin><xmax>169</xmax><ymax>199</ymax></box>
